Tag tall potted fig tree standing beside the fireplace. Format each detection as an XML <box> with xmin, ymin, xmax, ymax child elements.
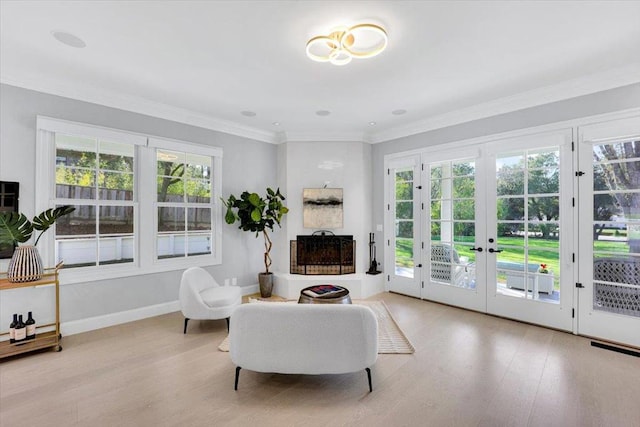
<box><xmin>222</xmin><ymin>188</ymin><xmax>289</xmax><ymax>298</ymax></box>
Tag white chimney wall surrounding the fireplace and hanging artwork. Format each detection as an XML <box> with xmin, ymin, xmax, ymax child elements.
<box><xmin>274</xmin><ymin>142</ymin><xmax>373</xmax><ymax>273</ymax></box>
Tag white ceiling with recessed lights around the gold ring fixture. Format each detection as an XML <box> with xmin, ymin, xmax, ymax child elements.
<box><xmin>0</xmin><ymin>0</ymin><xmax>640</xmax><ymax>142</ymax></box>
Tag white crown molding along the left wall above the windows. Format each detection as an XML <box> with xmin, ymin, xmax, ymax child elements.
<box><xmin>0</xmin><ymin>73</ymin><xmax>279</xmax><ymax>144</ymax></box>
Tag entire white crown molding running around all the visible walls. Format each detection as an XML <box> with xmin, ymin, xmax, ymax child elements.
<box><xmin>0</xmin><ymin>62</ymin><xmax>640</xmax><ymax>144</ymax></box>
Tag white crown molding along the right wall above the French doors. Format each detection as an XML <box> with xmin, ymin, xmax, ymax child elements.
<box><xmin>367</xmin><ymin>62</ymin><xmax>640</xmax><ymax>144</ymax></box>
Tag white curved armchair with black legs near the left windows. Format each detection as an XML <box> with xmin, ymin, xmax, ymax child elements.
<box><xmin>180</xmin><ymin>267</ymin><xmax>242</xmax><ymax>334</ymax></box>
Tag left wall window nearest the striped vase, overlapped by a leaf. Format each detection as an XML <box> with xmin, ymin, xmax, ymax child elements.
<box><xmin>54</xmin><ymin>133</ymin><xmax>137</xmax><ymax>268</ymax></box>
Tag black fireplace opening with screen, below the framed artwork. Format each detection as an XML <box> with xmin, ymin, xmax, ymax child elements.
<box><xmin>289</xmin><ymin>234</ymin><xmax>356</xmax><ymax>275</ymax></box>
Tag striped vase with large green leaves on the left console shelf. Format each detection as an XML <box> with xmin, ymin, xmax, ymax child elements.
<box><xmin>0</xmin><ymin>205</ymin><xmax>76</xmax><ymax>282</ymax></box>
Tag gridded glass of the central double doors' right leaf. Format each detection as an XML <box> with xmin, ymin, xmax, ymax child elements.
<box><xmin>495</xmin><ymin>147</ymin><xmax>560</xmax><ymax>304</ymax></box>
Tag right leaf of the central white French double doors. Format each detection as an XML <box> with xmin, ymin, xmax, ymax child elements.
<box><xmin>484</xmin><ymin>129</ymin><xmax>575</xmax><ymax>331</ymax></box>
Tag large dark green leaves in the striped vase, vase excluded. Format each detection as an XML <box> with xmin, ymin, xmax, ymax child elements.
<box><xmin>0</xmin><ymin>205</ymin><xmax>76</xmax><ymax>247</ymax></box>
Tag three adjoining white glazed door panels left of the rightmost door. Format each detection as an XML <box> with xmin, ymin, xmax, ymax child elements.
<box><xmin>387</xmin><ymin>130</ymin><xmax>573</xmax><ymax>330</ymax></box>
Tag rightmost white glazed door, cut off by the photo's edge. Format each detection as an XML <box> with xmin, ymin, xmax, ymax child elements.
<box><xmin>578</xmin><ymin>117</ymin><xmax>640</xmax><ymax>347</ymax></box>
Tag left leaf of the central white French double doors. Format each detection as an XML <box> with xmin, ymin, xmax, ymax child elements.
<box><xmin>422</xmin><ymin>149</ymin><xmax>486</xmax><ymax>311</ymax></box>
